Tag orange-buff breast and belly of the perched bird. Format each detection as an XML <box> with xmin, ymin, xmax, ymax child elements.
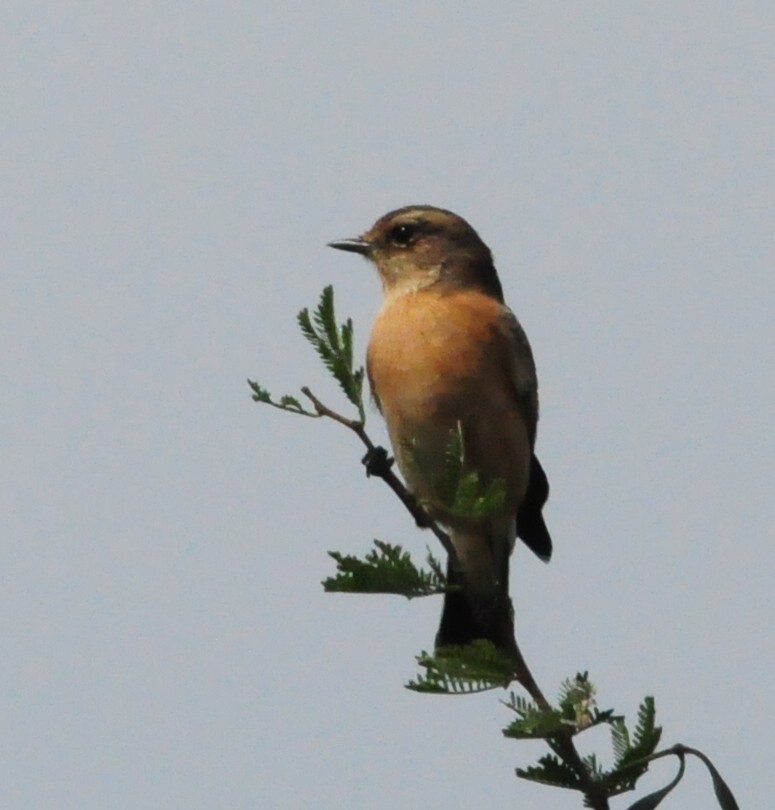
<box><xmin>367</xmin><ymin>289</ymin><xmax>530</xmax><ymax>520</ymax></box>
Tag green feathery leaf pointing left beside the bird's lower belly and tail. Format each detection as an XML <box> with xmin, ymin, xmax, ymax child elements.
<box><xmin>323</xmin><ymin>540</ymin><xmax>449</xmax><ymax>599</ymax></box>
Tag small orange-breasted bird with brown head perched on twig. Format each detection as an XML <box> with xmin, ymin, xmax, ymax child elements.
<box><xmin>328</xmin><ymin>205</ymin><xmax>552</xmax><ymax>657</ymax></box>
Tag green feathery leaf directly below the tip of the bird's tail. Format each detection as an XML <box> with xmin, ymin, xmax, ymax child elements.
<box><xmin>406</xmin><ymin>639</ymin><xmax>514</xmax><ymax>695</ymax></box>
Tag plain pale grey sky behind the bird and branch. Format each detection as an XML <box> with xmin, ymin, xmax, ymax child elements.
<box><xmin>0</xmin><ymin>0</ymin><xmax>775</xmax><ymax>810</ymax></box>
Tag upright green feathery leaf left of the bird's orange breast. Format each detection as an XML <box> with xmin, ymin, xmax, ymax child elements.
<box><xmin>297</xmin><ymin>284</ymin><xmax>366</xmax><ymax>422</ymax></box>
